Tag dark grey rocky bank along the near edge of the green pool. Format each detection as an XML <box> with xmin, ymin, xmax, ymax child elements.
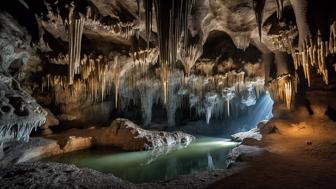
<box><xmin>0</xmin><ymin>162</ymin><xmax>241</xmax><ymax>189</ymax></box>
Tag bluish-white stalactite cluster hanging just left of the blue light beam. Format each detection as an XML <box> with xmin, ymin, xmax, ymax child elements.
<box><xmin>189</xmin><ymin>76</ymin><xmax>264</xmax><ymax>124</ymax></box>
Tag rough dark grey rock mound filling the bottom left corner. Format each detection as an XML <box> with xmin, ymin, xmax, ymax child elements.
<box><xmin>0</xmin><ymin>162</ymin><xmax>135</xmax><ymax>189</ymax></box>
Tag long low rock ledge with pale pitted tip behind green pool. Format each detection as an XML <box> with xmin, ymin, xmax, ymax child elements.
<box><xmin>0</xmin><ymin>119</ymin><xmax>195</xmax><ymax>166</ymax></box>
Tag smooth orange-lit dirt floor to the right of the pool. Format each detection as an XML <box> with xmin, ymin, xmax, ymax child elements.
<box><xmin>208</xmin><ymin>118</ymin><xmax>336</xmax><ymax>189</ymax></box>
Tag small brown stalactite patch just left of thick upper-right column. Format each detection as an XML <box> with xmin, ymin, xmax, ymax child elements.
<box><xmin>271</xmin><ymin>25</ymin><xmax>298</xmax><ymax>54</ymax></box>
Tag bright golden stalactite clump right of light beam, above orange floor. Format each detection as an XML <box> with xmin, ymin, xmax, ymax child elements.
<box><xmin>268</xmin><ymin>74</ymin><xmax>298</xmax><ymax>110</ymax></box>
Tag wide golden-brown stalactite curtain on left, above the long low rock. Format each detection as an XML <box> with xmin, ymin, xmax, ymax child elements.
<box><xmin>46</xmin><ymin>48</ymin><xmax>158</xmax><ymax>108</ymax></box>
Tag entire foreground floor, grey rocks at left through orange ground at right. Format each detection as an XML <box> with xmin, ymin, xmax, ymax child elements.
<box><xmin>0</xmin><ymin>117</ymin><xmax>336</xmax><ymax>189</ymax></box>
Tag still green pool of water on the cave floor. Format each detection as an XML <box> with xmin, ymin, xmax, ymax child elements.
<box><xmin>47</xmin><ymin>138</ymin><xmax>237</xmax><ymax>183</ymax></box>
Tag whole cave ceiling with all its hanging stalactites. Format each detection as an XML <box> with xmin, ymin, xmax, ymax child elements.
<box><xmin>0</xmin><ymin>0</ymin><xmax>336</xmax><ymax>143</ymax></box>
